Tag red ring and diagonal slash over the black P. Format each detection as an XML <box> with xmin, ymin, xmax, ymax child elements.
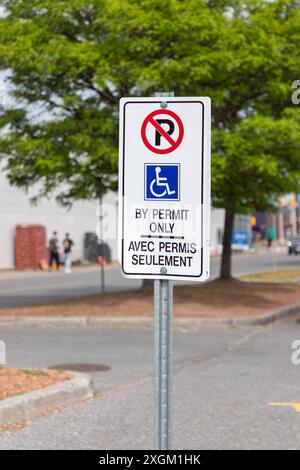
<box><xmin>141</xmin><ymin>109</ymin><xmax>184</xmax><ymax>154</ymax></box>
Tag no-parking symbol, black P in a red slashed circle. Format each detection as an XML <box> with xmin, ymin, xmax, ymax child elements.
<box><xmin>141</xmin><ymin>109</ymin><xmax>184</xmax><ymax>154</ymax></box>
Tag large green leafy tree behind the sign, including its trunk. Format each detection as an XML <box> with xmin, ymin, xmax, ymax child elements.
<box><xmin>0</xmin><ymin>0</ymin><xmax>300</xmax><ymax>278</ymax></box>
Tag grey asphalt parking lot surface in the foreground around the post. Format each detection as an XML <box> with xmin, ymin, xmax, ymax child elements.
<box><xmin>0</xmin><ymin>319</ymin><xmax>300</xmax><ymax>449</ymax></box>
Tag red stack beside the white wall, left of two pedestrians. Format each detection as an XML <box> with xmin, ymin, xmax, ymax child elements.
<box><xmin>15</xmin><ymin>224</ymin><xmax>48</xmax><ymax>269</ymax></box>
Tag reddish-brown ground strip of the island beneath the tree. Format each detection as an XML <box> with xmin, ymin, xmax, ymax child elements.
<box><xmin>0</xmin><ymin>278</ymin><xmax>300</xmax><ymax>318</ymax></box>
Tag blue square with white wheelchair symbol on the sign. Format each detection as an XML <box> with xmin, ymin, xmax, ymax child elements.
<box><xmin>145</xmin><ymin>163</ymin><xmax>180</xmax><ymax>201</ymax></box>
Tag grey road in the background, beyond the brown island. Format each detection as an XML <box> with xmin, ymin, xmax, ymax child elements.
<box><xmin>0</xmin><ymin>252</ymin><xmax>300</xmax><ymax>308</ymax></box>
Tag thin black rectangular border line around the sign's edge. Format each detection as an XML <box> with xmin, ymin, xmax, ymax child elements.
<box><xmin>121</xmin><ymin>100</ymin><xmax>205</xmax><ymax>279</ymax></box>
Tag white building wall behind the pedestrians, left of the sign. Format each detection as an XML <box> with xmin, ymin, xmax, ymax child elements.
<box><xmin>0</xmin><ymin>173</ymin><xmax>117</xmax><ymax>269</ymax></box>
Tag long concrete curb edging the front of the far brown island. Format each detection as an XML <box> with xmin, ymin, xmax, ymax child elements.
<box><xmin>0</xmin><ymin>302</ymin><xmax>300</xmax><ymax>328</ymax></box>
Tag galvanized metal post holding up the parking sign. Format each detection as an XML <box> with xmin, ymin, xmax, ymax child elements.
<box><xmin>153</xmin><ymin>93</ymin><xmax>174</xmax><ymax>450</ymax></box>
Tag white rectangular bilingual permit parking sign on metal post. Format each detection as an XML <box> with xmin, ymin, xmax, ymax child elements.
<box><xmin>119</xmin><ymin>97</ymin><xmax>210</xmax><ymax>281</ymax></box>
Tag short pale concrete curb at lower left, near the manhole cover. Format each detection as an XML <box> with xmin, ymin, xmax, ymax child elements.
<box><xmin>0</xmin><ymin>371</ymin><xmax>93</xmax><ymax>426</ymax></box>
